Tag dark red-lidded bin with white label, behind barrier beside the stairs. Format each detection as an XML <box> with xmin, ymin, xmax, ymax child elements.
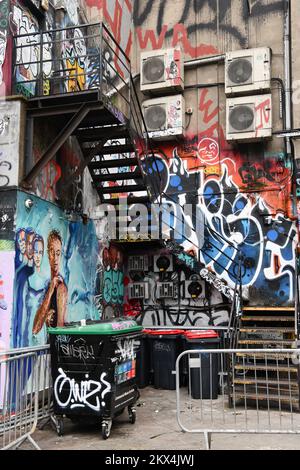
<box><xmin>185</xmin><ymin>330</ymin><xmax>220</xmax><ymax>400</ymax></box>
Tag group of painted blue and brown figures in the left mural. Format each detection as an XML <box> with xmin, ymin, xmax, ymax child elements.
<box><xmin>12</xmin><ymin>227</ymin><xmax>68</xmax><ymax>347</ymax></box>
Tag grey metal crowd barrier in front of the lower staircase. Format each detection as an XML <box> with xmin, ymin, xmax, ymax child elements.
<box><xmin>176</xmin><ymin>349</ymin><xmax>300</xmax><ymax>450</ymax></box>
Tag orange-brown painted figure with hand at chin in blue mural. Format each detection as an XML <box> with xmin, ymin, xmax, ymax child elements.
<box><xmin>32</xmin><ymin>230</ymin><xmax>68</xmax><ymax>334</ymax></box>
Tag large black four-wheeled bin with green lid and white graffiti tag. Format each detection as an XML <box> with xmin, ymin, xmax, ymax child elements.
<box><xmin>48</xmin><ymin>318</ymin><xmax>142</xmax><ymax>439</ymax></box>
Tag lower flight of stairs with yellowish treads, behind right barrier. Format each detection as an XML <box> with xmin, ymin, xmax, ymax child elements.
<box><xmin>229</xmin><ymin>306</ymin><xmax>299</xmax><ymax>410</ymax></box>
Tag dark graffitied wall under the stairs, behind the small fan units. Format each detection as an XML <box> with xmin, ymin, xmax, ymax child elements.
<box><xmin>124</xmin><ymin>250</ymin><xmax>230</xmax><ymax>327</ymax></box>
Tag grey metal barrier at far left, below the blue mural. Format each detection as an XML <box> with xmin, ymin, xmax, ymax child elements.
<box><xmin>0</xmin><ymin>346</ymin><xmax>51</xmax><ymax>450</ymax></box>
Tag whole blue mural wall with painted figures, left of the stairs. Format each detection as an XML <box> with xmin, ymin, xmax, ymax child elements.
<box><xmin>11</xmin><ymin>192</ymin><xmax>100</xmax><ymax>347</ymax></box>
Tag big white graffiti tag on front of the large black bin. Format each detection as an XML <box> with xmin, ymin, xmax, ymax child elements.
<box><xmin>54</xmin><ymin>368</ymin><xmax>111</xmax><ymax>411</ymax></box>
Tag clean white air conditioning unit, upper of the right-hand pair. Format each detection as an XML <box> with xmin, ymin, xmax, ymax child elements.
<box><xmin>225</xmin><ymin>47</ymin><xmax>271</xmax><ymax>96</ymax></box>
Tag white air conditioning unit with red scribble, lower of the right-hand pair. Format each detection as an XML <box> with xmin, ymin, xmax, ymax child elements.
<box><xmin>226</xmin><ymin>94</ymin><xmax>272</xmax><ymax>142</ymax></box>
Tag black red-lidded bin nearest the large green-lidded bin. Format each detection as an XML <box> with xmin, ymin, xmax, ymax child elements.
<box><xmin>148</xmin><ymin>330</ymin><xmax>182</xmax><ymax>390</ymax></box>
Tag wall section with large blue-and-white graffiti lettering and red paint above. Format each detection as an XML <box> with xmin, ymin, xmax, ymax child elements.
<box><xmin>142</xmin><ymin>89</ymin><xmax>296</xmax><ymax>305</ymax></box>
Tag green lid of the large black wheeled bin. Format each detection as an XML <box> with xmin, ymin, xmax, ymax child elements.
<box><xmin>48</xmin><ymin>318</ymin><xmax>143</xmax><ymax>335</ymax></box>
